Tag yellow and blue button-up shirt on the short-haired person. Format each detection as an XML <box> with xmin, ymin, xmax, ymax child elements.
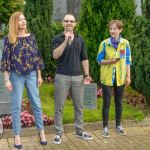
<box><xmin>97</xmin><ymin>37</ymin><xmax>131</xmax><ymax>86</ymax></box>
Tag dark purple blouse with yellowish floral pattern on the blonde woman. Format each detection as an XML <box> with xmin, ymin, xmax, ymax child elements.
<box><xmin>1</xmin><ymin>35</ymin><xmax>44</xmax><ymax>75</ymax></box>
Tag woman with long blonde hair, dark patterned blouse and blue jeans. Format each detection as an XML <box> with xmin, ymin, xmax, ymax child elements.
<box><xmin>2</xmin><ymin>12</ymin><xmax>47</xmax><ymax>149</ymax></box>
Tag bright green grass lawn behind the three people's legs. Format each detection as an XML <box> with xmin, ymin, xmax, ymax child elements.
<box><xmin>24</xmin><ymin>83</ymin><xmax>144</xmax><ymax>123</ymax></box>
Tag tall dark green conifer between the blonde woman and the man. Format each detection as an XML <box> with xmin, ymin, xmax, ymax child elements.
<box><xmin>24</xmin><ymin>0</ymin><xmax>53</xmax><ymax>76</ymax></box>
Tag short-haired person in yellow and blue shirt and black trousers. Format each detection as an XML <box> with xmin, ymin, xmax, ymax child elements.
<box><xmin>97</xmin><ymin>20</ymin><xmax>131</xmax><ymax>137</ymax></box>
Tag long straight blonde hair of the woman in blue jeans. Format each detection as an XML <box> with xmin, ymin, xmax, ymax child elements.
<box><xmin>8</xmin><ymin>12</ymin><xmax>28</xmax><ymax>44</ymax></box>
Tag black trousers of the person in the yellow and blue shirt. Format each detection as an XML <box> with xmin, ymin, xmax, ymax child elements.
<box><xmin>102</xmin><ymin>82</ymin><xmax>124</xmax><ymax>127</ymax></box>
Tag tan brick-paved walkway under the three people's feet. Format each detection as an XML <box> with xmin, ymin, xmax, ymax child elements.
<box><xmin>0</xmin><ymin>126</ymin><xmax>150</xmax><ymax>150</ymax></box>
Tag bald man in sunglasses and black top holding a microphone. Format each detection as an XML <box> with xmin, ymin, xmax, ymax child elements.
<box><xmin>52</xmin><ymin>14</ymin><xmax>92</xmax><ymax>144</ymax></box>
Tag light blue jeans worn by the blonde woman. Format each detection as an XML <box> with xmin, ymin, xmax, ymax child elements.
<box><xmin>10</xmin><ymin>71</ymin><xmax>44</xmax><ymax>135</ymax></box>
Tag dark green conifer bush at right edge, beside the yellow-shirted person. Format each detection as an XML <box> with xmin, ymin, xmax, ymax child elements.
<box><xmin>130</xmin><ymin>16</ymin><xmax>150</xmax><ymax>104</ymax></box>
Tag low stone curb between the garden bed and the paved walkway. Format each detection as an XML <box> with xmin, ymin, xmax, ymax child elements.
<box><xmin>3</xmin><ymin>118</ymin><xmax>150</xmax><ymax>138</ymax></box>
